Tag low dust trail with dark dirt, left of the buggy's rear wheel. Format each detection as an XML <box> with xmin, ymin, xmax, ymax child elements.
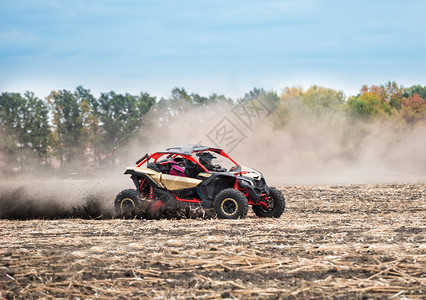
<box><xmin>0</xmin><ymin>178</ymin><xmax>113</xmax><ymax>220</ymax></box>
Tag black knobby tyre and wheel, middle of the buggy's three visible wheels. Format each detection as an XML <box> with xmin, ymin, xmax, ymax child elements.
<box><xmin>213</xmin><ymin>188</ymin><xmax>248</xmax><ymax>219</ymax></box>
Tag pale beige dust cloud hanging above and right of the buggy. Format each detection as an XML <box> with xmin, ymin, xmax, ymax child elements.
<box><xmin>129</xmin><ymin>101</ymin><xmax>426</xmax><ymax>186</ymax></box>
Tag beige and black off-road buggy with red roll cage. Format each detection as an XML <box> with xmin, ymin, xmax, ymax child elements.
<box><xmin>114</xmin><ymin>145</ymin><xmax>285</xmax><ymax>219</ymax></box>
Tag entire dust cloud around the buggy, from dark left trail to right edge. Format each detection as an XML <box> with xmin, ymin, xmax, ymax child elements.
<box><xmin>0</xmin><ymin>99</ymin><xmax>426</xmax><ymax>219</ymax></box>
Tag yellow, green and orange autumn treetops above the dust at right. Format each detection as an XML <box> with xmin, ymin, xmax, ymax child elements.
<box><xmin>278</xmin><ymin>82</ymin><xmax>426</xmax><ymax>126</ymax></box>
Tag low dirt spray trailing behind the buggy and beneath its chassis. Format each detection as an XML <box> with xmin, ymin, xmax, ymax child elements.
<box><xmin>0</xmin><ymin>178</ymin><xmax>215</xmax><ymax>220</ymax></box>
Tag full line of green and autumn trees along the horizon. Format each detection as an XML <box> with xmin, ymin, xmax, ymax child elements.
<box><xmin>0</xmin><ymin>82</ymin><xmax>426</xmax><ymax>170</ymax></box>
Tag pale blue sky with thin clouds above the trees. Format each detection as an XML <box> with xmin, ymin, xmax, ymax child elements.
<box><xmin>0</xmin><ymin>0</ymin><xmax>426</xmax><ymax>98</ymax></box>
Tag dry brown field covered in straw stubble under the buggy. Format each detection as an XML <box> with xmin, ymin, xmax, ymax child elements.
<box><xmin>0</xmin><ymin>184</ymin><xmax>426</xmax><ymax>299</ymax></box>
